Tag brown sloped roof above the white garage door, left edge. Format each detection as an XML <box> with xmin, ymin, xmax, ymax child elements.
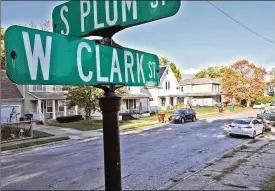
<box><xmin>1</xmin><ymin>70</ymin><xmax>23</xmax><ymax>99</ymax></box>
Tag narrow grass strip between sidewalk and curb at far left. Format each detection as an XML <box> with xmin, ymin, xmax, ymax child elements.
<box><xmin>1</xmin><ymin>137</ymin><xmax>70</xmax><ymax>151</ymax></box>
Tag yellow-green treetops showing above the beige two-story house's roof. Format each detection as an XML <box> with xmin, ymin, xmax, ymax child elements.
<box><xmin>194</xmin><ymin>66</ymin><xmax>225</xmax><ymax>79</ymax></box>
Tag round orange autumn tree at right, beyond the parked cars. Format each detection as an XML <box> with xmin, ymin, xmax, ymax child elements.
<box><xmin>221</xmin><ymin>60</ymin><xmax>267</xmax><ymax>107</ymax></box>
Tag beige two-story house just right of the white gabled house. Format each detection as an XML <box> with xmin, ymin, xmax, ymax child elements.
<box><xmin>180</xmin><ymin>78</ymin><xmax>222</xmax><ymax>107</ymax></box>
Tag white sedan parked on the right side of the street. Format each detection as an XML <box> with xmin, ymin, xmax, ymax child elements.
<box><xmin>229</xmin><ymin>118</ymin><xmax>265</xmax><ymax>139</ymax></box>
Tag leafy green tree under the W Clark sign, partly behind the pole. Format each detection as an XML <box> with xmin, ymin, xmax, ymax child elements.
<box><xmin>63</xmin><ymin>86</ymin><xmax>127</xmax><ymax>117</ymax></box>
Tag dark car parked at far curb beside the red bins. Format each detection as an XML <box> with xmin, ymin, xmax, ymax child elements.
<box><xmin>169</xmin><ymin>108</ymin><xmax>196</xmax><ymax>123</ymax></box>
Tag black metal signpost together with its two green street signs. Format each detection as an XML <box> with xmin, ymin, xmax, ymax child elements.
<box><xmin>5</xmin><ymin>0</ymin><xmax>181</xmax><ymax>191</ymax></box>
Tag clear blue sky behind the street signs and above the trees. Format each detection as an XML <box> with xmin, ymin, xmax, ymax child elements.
<box><xmin>1</xmin><ymin>1</ymin><xmax>275</xmax><ymax>77</ymax></box>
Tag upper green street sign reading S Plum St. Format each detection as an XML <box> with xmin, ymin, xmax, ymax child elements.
<box><xmin>52</xmin><ymin>0</ymin><xmax>181</xmax><ymax>37</ymax></box>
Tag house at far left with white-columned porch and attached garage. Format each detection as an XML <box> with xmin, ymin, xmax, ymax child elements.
<box><xmin>1</xmin><ymin>71</ymin><xmax>73</xmax><ymax>121</ymax></box>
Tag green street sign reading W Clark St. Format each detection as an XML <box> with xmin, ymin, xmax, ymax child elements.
<box><xmin>5</xmin><ymin>26</ymin><xmax>159</xmax><ymax>86</ymax></box>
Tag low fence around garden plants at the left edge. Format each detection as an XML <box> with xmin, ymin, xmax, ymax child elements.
<box><xmin>1</xmin><ymin>121</ymin><xmax>33</xmax><ymax>142</ymax></box>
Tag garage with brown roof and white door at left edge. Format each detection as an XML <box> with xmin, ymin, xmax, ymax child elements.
<box><xmin>0</xmin><ymin>70</ymin><xmax>24</xmax><ymax>123</ymax></box>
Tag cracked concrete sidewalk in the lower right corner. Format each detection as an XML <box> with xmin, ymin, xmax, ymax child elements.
<box><xmin>166</xmin><ymin>134</ymin><xmax>275</xmax><ymax>190</ymax></box>
